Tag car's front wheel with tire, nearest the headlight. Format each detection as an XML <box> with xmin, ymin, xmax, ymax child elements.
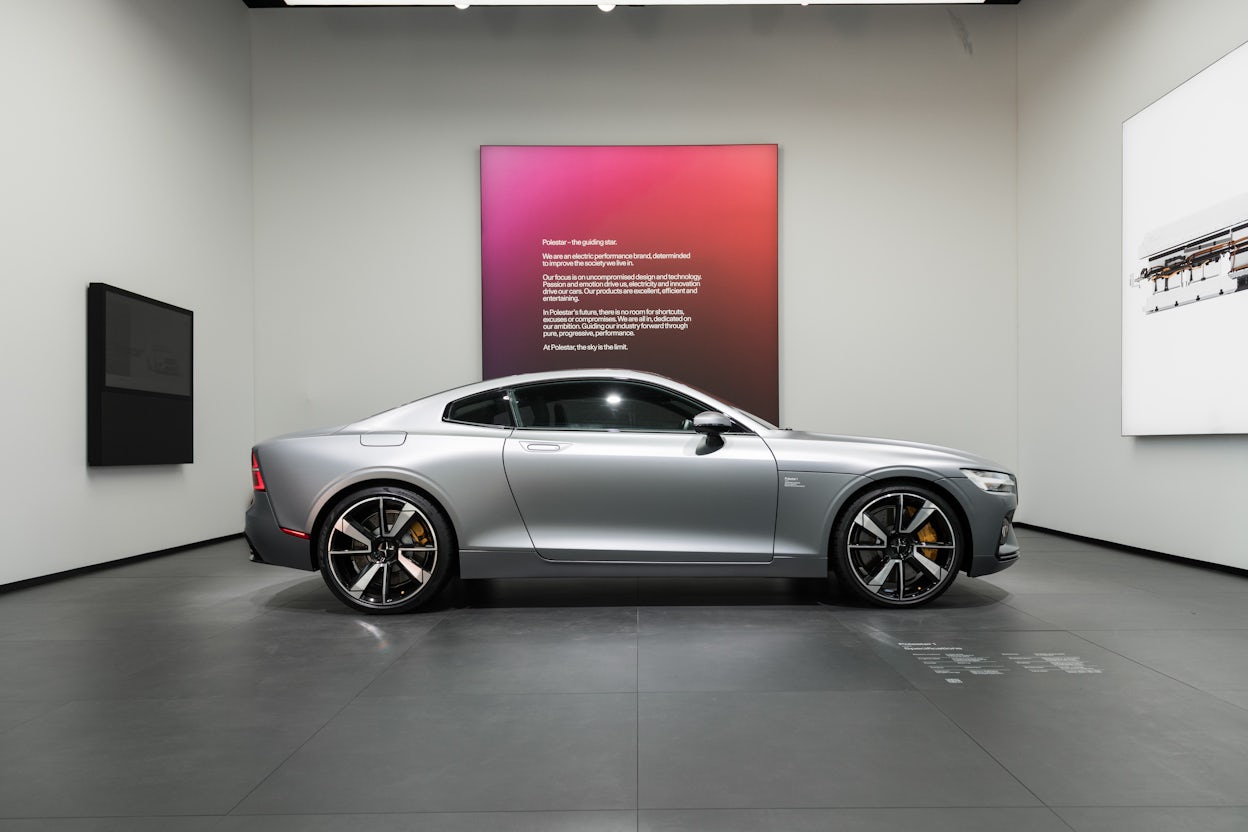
<box><xmin>830</xmin><ymin>483</ymin><xmax>967</xmax><ymax>606</ymax></box>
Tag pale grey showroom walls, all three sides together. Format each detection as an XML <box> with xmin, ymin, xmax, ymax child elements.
<box><xmin>12</xmin><ymin>0</ymin><xmax>1248</xmax><ymax>584</ymax></box>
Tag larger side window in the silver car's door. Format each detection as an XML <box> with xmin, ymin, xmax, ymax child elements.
<box><xmin>515</xmin><ymin>379</ymin><xmax>706</xmax><ymax>432</ymax></box>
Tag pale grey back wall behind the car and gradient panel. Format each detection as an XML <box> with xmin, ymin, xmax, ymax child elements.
<box><xmin>252</xmin><ymin>6</ymin><xmax>1017</xmax><ymax>474</ymax></box>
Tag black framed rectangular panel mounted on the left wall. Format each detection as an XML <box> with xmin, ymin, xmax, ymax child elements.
<box><xmin>86</xmin><ymin>283</ymin><xmax>195</xmax><ymax>465</ymax></box>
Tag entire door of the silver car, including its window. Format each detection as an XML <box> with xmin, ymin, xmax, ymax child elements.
<box><xmin>503</xmin><ymin>379</ymin><xmax>778</xmax><ymax>563</ymax></box>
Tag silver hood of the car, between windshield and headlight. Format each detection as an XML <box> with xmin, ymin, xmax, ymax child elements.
<box><xmin>766</xmin><ymin>430</ymin><xmax>1012</xmax><ymax>476</ymax></box>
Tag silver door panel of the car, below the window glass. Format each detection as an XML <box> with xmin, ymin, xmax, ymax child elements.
<box><xmin>503</xmin><ymin>430</ymin><xmax>776</xmax><ymax>563</ymax></box>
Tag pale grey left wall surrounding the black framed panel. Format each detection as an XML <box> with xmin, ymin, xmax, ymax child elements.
<box><xmin>0</xmin><ymin>0</ymin><xmax>253</xmax><ymax>584</ymax></box>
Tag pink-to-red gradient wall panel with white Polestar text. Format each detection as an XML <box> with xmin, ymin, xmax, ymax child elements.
<box><xmin>480</xmin><ymin>145</ymin><xmax>779</xmax><ymax>422</ymax></box>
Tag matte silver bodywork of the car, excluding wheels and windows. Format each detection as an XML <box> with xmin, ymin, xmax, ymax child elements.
<box><xmin>238</xmin><ymin>369</ymin><xmax>1017</xmax><ymax>591</ymax></box>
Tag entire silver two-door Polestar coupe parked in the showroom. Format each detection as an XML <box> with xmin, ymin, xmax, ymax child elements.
<box><xmin>246</xmin><ymin>369</ymin><xmax>1018</xmax><ymax>612</ymax></box>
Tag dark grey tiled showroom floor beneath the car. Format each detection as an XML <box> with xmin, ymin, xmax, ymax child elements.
<box><xmin>0</xmin><ymin>530</ymin><xmax>1248</xmax><ymax>832</ymax></box>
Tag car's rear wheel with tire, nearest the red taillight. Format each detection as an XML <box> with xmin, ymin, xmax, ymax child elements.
<box><xmin>317</xmin><ymin>486</ymin><xmax>457</xmax><ymax>615</ymax></box>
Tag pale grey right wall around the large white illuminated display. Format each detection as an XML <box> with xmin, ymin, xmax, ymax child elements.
<box><xmin>1018</xmin><ymin>0</ymin><xmax>1248</xmax><ymax>569</ymax></box>
